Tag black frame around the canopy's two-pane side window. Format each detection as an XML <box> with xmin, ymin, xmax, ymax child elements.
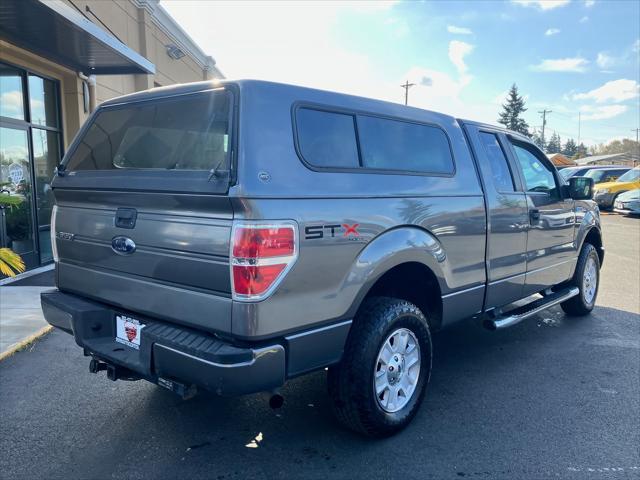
<box><xmin>291</xmin><ymin>102</ymin><xmax>457</xmax><ymax>178</ymax></box>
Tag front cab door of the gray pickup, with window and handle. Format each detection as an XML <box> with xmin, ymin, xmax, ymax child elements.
<box><xmin>509</xmin><ymin>136</ymin><xmax>577</xmax><ymax>295</ymax></box>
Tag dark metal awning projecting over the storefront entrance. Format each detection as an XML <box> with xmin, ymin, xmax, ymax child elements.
<box><xmin>0</xmin><ymin>0</ymin><xmax>156</xmax><ymax>75</ymax></box>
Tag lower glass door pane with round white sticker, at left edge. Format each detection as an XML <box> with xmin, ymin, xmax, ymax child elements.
<box><xmin>0</xmin><ymin>122</ymin><xmax>39</xmax><ymax>267</ymax></box>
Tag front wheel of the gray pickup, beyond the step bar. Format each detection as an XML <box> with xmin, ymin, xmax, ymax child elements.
<box><xmin>560</xmin><ymin>243</ymin><xmax>600</xmax><ymax>316</ymax></box>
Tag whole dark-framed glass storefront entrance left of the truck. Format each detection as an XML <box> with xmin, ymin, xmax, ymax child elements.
<box><xmin>0</xmin><ymin>63</ymin><xmax>62</xmax><ymax>270</ymax></box>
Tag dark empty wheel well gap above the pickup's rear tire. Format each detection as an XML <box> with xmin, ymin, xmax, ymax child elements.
<box><xmin>365</xmin><ymin>262</ymin><xmax>442</xmax><ymax>330</ymax></box>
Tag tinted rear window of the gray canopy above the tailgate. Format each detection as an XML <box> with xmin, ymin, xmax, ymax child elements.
<box><xmin>65</xmin><ymin>90</ymin><xmax>231</xmax><ymax>171</ymax></box>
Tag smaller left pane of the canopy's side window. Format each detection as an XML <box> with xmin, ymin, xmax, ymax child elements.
<box><xmin>296</xmin><ymin>108</ymin><xmax>360</xmax><ymax>168</ymax></box>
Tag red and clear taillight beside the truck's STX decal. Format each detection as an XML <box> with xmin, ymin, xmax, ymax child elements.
<box><xmin>231</xmin><ymin>224</ymin><xmax>297</xmax><ymax>300</ymax></box>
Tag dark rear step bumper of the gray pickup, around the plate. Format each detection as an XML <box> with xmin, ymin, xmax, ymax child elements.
<box><xmin>41</xmin><ymin>290</ymin><xmax>286</xmax><ymax>396</ymax></box>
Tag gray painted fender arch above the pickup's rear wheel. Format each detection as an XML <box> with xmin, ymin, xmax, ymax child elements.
<box><xmin>341</xmin><ymin>227</ymin><xmax>451</xmax><ymax>317</ymax></box>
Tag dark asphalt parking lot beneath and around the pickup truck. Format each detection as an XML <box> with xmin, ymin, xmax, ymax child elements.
<box><xmin>0</xmin><ymin>215</ymin><xmax>640</xmax><ymax>480</ymax></box>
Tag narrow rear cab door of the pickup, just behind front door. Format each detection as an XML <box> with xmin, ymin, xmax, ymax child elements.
<box><xmin>465</xmin><ymin>124</ymin><xmax>529</xmax><ymax>310</ymax></box>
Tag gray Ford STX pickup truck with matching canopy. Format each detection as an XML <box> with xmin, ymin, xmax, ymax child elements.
<box><xmin>42</xmin><ymin>81</ymin><xmax>604</xmax><ymax>436</ymax></box>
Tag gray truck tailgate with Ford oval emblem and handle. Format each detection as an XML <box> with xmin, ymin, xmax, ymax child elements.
<box><xmin>54</xmin><ymin>188</ymin><xmax>233</xmax><ymax>332</ymax></box>
